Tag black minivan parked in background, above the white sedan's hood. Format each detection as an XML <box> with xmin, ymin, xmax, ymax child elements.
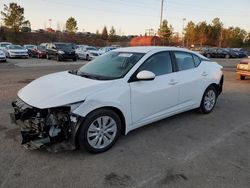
<box><xmin>46</xmin><ymin>43</ymin><xmax>78</xmax><ymax>61</ymax></box>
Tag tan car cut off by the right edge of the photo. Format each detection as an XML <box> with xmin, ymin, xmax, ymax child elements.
<box><xmin>236</xmin><ymin>59</ymin><xmax>250</xmax><ymax>80</ymax></box>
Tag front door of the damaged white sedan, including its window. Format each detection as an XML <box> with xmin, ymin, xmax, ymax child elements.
<box><xmin>130</xmin><ymin>52</ymin><xmax>179</xmax><ymax>125</ymax></box>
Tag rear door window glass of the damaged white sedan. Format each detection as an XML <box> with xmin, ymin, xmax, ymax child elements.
<box><xmin>174</xmin><ymin>52</ymin><xmax>195</xmax><ymax>71</ymax></box>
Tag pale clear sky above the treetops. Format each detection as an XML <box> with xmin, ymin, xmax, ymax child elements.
<box><xmin>0</xmin><ymin>0</ymin><xmax>250</xmax><ymax>35</ymax></box>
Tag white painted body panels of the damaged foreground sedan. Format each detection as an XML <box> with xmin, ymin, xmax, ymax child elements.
<box><xmin>18</xmin><ymin>47</ymin><xmax>222</xmax><ymax>133</ymax></box>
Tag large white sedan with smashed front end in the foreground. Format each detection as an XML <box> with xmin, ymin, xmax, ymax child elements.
<box><xmin>11</xmin><ymin>47</ymin><xmax>223</xmax><ymax>153</ymax></box>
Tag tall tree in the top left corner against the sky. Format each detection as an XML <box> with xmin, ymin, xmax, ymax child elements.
<box><xmin>1</xmin><ymin>3</ymin><xmax>30</xmax><ymax>32</ymax></box>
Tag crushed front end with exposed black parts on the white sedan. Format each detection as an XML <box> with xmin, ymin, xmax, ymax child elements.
<box><xmin>10</xmin><ymin>98</ymin><xmax>79</xmax><ymax>151</ymax></box>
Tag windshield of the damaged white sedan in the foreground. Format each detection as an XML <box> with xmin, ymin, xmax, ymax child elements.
<box><xmin>78</xmin><ymin>51</ymin><xmax>144</xmax><ymax>79</ymax></box>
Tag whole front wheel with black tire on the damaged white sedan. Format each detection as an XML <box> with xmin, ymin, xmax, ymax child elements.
<box><xmin>78</xmin><ymin>109</ymin><xmax>121</xmax><ymax>154</ymax></box>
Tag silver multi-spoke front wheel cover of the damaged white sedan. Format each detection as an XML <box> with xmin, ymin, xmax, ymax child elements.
<box><xmin>87</xmin><ymin>116</ymin><xmax>117</xmax><ymax>149</ymax></box>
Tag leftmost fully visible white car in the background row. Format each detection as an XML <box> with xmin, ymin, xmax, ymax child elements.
<box><xmin>5</xmin><ymin>45</ymin><xmax>29</xmax><ymax>58</ymax></box>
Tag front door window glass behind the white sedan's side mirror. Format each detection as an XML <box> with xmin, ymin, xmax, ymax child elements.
<box><xmin>139</xmin><ymin>52</ymin><xmax>172</xmax><ymax>76</ymax></box>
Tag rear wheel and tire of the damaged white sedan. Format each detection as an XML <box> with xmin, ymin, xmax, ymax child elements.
<box><xmin>199</xmin><ymin>86</ymin><xmax>218</xmax><ymax>114</ymax></box>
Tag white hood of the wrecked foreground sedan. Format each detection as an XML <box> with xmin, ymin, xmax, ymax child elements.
<box><xmin>18</xmin><ymin>71</ymin><xmax>113</xmax><ymax>109</ymax></box>
